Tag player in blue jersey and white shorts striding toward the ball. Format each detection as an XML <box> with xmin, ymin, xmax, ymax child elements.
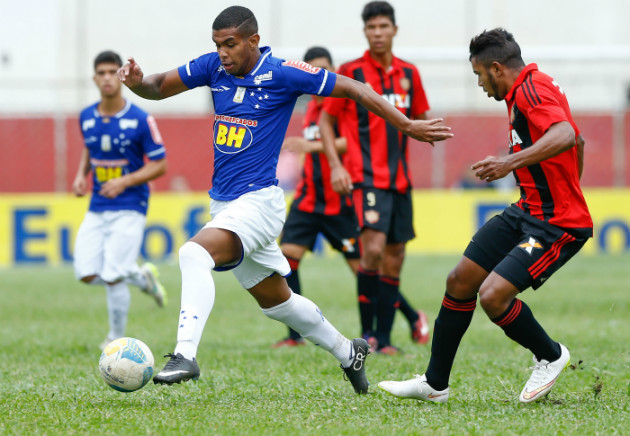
<box><xmin>118</xmin><ymin>6</ymin><xmax>452</xmax><ymax>393</ymax></box>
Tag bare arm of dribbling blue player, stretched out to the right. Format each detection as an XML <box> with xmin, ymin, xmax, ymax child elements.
<box><xmin>330</xmin><ymin>74</ymin><xmax>453</xmax><ymax>142</ymax></box>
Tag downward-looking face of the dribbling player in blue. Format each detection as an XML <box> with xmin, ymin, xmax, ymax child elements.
<box><xmin>212</xmin><ymin>27</ymin><xmax>260</xmax><ymax>76</ymax></box>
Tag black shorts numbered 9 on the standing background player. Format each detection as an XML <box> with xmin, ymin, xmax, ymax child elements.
<box><xmin>352</xmin><ymin>188</ymin><xmax>416</xmax><ymax>244</ymax></box>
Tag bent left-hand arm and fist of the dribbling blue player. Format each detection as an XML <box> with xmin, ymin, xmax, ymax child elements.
<box><xmin>117</xmin><ymin>57</ymin><xmax>188</xmax><ymax>100</ymax></box>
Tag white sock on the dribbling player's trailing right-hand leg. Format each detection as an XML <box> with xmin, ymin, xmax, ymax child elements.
<box><xmin>262</xmin><ymin>293</ymin><xmax>352</xmax><ymax>368</ymax></box>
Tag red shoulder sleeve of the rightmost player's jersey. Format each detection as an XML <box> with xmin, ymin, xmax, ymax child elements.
<box><xmin>516</xmin><ymin>81</ymin><xmax>569</xmax><ymax>133</ymax></box>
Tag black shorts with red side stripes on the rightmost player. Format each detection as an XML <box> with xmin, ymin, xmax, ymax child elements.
<box><xmin>464</xmin><ymin>205</ymin><xmax>593</xmax><ymax>292</ymax></box>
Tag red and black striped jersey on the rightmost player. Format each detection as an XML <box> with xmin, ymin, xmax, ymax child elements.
<box><xmin>505</xmin><ymin>64</ymin><xmax>593</xmax><ymax>229</ymax></box>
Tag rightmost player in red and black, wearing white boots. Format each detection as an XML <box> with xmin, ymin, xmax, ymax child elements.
<box><xmin>379</xmin><ymin>28</ymin><xmax>593</xmax><ymax>403</ymax></box>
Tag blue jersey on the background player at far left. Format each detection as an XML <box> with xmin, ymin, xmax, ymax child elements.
<box><xmin>79</xmin><ymin>102</ymin><xmax>166</xmax><ymax>215</ymax></box>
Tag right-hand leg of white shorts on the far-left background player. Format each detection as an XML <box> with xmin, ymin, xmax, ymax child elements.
<box><xmin>101</xmin><ymin>210</ymin><xmax>146</xmax><ymax>282</ymax></box>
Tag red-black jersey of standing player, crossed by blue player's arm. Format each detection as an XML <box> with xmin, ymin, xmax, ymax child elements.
<box><xmin>324</xmin><ymin>50</ymin><xmax>429</xmax><ymax>192</ymax></box>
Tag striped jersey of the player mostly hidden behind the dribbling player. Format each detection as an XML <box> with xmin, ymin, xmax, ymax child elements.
<box><xmin>292</xmin><ymin>96</ymin><xmax>352</xmax><ymax>215</ymax></box>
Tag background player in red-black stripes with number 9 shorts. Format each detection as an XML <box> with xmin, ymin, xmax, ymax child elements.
<box><xmin>320</xmin><ymin>1</ymin><xmax>429</xmax><ymax>354</ymax></box>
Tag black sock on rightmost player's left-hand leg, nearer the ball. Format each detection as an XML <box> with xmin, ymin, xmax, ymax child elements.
<box><xmin>426</xmin><ymin>294</ymin><xmax>477</xmax><ymax>391</ymax></box>
